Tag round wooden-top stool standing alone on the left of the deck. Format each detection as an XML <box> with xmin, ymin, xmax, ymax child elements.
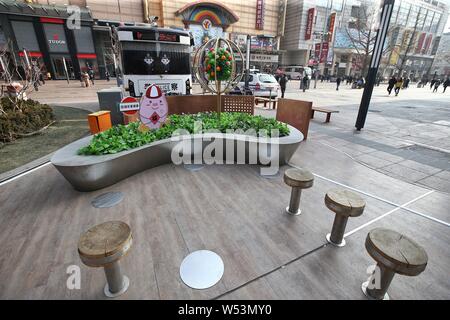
<box><xmin>78</xmin><ymin>221</ymin><xmax>132</xmax><ymax>298</ymax></box>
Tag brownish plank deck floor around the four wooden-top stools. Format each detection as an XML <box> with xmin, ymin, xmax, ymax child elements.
<box><xmin>0</xmin><ymin>140</ymin><xmax>450</xmax><ymax>299</ymax></box>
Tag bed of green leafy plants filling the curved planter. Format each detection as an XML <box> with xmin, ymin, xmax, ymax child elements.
<box><xmin>78</xmin><ymin>112</ymin><xmax>289</xmax><ymax>155</ymax></box>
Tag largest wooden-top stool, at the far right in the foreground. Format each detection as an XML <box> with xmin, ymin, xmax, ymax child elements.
<box><xmin>361</xmin><ymin>228</ymin><xmax>428</xmax><ymax>300</ymax></box>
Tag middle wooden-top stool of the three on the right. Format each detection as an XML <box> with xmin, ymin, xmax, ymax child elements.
<box><xmin>325</xmin><ymin>189</ymin><xmax>366</xmax><ymax>247</ymax></box>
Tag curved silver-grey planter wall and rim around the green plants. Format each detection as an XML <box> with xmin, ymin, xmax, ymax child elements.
<box><xmin>50</xmin><ymin>125</ymin><xmax>303</xmax><ymax>191</ymax></box>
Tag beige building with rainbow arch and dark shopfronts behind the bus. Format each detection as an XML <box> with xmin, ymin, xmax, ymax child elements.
<box><xmin>0</xmin><ymin>0</ymin><xmax>287</xmax><ymax>79</ymax></box>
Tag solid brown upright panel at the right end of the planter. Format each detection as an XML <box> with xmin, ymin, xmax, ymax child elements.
<box><xmin>276</xmin><ymin>98</ymin><xmax>312</xmax><ymax>139</ymax></box>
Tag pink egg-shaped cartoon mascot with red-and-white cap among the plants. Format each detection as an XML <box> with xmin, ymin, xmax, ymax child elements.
<box><xmin>139</xmin><ymin>84</ymin><xmax>169</xmax><ymax>129</ymax></box>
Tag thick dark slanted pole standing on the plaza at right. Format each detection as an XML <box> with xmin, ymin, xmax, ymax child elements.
<box><xmin>355</xmin><ymin>0</ymin><xmax>395</xmax><ymax>131</ymax></box>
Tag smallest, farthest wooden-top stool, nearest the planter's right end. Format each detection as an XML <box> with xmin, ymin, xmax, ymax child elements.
<box><xmin>284</xmin><ymin>168</ymin><xmax>314</xmax><ymax>216</ymax></box>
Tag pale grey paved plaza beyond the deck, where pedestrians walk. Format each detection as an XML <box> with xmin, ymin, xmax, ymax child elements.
<box><xmin>27</xmin><ymin>79</ymin><xmax>450</xmax><ymax>193</ymax></box>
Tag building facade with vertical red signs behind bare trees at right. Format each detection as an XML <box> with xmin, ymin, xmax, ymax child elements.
<box><xmin>281</xmin><ymin>0</ymin><xmax>449</xmax><ymax>78</ymax></box>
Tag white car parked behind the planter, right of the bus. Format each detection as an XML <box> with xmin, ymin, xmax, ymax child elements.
<box><xmin>230</xmin><ymin>73</ymin><xmax>280</xmax><ymax>98</ymax></box>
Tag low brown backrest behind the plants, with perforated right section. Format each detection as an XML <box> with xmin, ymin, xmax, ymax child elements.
<box><xmin>166</xmin><ymin>94</ymin><xmax>255</xmax><ymax>114</ymax></box>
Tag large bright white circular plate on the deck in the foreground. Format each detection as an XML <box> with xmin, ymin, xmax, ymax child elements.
<box><xmin>180</xmin><ymin>250</ymin><xmax>224</xmax><ymax>289</ymax></box>
